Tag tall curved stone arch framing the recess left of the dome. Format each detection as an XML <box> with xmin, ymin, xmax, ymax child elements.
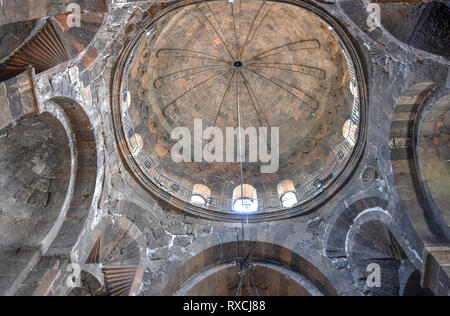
<box><xmin>35</xmin><ymin>67</ymin><xmax>105</xmax><ymax>259</ymax></box>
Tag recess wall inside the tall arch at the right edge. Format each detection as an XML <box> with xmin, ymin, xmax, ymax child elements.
<box><xmin>414</xmin><ymin>89</ymin><xmax>450</xmax><ymax>296</ymax></box>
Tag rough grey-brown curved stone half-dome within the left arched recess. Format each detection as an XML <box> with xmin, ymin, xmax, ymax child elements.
<box><xmin>0</xmin><ymin>115</ymin><xmax>71</xmax><ymax>248</ymax></box>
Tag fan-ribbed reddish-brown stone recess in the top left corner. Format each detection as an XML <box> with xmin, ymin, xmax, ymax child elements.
<box><xmin>0</xmin><ymin>0</ymin><xmax>108</xmax><ymax>81</ymax></box>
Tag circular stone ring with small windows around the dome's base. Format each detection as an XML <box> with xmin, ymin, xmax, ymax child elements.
<box><xmin>113</xmin><ymin>1</ymin><xmax>367</xmax><ymax>222</ymax></box>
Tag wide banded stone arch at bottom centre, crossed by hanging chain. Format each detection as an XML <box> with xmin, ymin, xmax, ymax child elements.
<box><xmin>154</xmin><ymin>229</ymin><xmax>359</xmax><ymax>296</ymax></box>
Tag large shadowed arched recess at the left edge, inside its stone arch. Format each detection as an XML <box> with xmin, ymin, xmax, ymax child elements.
<box><xmin>0</xmin><ymin>113</ymin><xmax>76</xmax><ymax>295</ymax></box>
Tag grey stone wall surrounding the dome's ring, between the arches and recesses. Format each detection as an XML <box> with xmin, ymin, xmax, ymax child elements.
<box><xmin>46</xmin><ymin>0</ymin><xmax>447</xmax><ymax>295</ymax></box>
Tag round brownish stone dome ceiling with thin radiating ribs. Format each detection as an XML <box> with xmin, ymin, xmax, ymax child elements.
<box><xmin>116</xmin><ymin>1</ymin><xmax>360</xmax><ymax>220</ymax></box>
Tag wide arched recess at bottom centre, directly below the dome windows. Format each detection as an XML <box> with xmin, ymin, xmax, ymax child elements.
<box><xmin>162</xmin><ymin>241</ymin><xmax>358</xmax><ymax>296</ymax></box>
